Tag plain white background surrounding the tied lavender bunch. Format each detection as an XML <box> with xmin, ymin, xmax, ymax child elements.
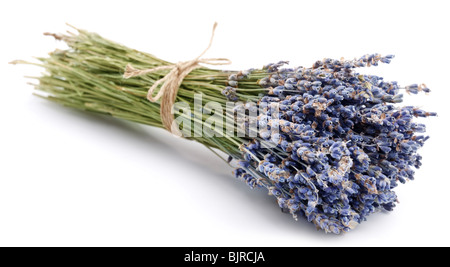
<box><xmin>0</xmin><ymin>0</ymin><xmax>450</xmax><ymax>246</ymax></box>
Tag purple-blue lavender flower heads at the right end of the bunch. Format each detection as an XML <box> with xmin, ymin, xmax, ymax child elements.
<box><xmin>229</xmin><ymin>54</ymin><xmax>436</xmax><ymax>234</ymax></box>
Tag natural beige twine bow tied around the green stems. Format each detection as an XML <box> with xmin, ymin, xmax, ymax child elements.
<box><xmin>123</xmin><ymin>22</ymin><xmax>231</xmax><ymax>136</ymax></box>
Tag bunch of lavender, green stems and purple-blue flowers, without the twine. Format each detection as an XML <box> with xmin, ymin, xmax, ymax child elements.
<box><xmin>14</xmin><ymin>27</ymin><xmax>436</xmax><ymax>234</ymax></box>
